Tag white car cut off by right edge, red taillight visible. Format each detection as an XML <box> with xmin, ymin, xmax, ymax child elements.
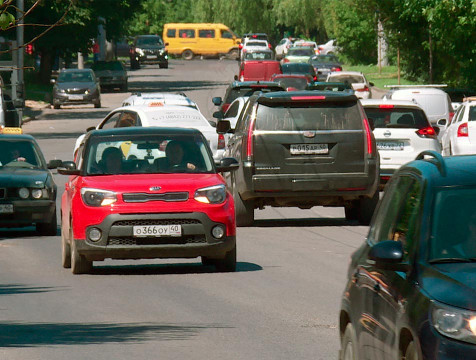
<box><xmin>438</xmin><ymin>97</ymin><xmax>476</xmax><ymax>156</ymax></box>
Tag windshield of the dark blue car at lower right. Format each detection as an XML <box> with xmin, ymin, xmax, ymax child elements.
<box><xmin>429</xmin><ymin>187</ymin><xmax>476</xmax><ymax>262</ymax></box>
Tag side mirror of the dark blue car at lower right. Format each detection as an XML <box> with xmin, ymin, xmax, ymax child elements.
<box><xmin>368</xmin><ymin>240</ymin><xmax>409</xmax><ymax>271</ymax></box>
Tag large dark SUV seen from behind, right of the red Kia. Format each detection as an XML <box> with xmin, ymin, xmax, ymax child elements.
<box><xmin>217</xmin><ymin>91</ymin><xmax>379</xmax><ymax>226</ymax></box>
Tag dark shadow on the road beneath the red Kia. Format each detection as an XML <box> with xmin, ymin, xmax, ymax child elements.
<box><xmin>90</xmin><ymin>262</ymin><xmax>263</xmax><ymax>275</ymax></box>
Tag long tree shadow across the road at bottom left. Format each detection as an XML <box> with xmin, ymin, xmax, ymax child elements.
<box><xmin>0</xmin><ymin>321</ymin><xmax>232</xmax><ymax>347</ymax></box>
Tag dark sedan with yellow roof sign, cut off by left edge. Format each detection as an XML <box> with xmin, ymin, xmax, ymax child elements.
<box><xmin>0</xmin><ymin>128</ymin><xmax>60</xmax><ymax>235</ymax></box>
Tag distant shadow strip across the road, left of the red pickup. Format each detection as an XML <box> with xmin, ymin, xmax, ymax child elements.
<box><xmin>129</xmin><ymin>81</ymin><xmax>231</xmax><ymax>92</ymax></box>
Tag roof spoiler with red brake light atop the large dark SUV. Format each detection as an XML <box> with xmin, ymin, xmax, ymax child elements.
<box><xmin>257</xmin><ymin>90</ymin><xmax>357</xmax><ymax>103</ymax></box>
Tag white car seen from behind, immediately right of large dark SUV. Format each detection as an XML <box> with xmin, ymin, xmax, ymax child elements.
<box><xmin>360</xmin><ymin>99</ymin><xmax>441</xmax><ymax>184</ymax></box>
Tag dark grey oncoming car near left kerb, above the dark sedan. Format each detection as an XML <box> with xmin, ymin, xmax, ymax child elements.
<box><xmin>51</xmin><ymin>69</ymin><xmax>101</xmax><ymax>109</ymax></box>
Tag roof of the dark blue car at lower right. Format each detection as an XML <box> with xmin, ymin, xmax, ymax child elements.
<box><xmin>399</xmin><ymin>154</ymin><xmax>476</xmax><ymax>187</ymax></box>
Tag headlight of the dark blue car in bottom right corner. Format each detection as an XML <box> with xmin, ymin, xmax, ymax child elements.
<box><xmin>431</xmin><ymin>303</ymin><xmax>476</xmax><ymax>344</ymax></box>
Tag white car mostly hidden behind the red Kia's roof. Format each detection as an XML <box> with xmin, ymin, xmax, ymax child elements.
<box><xmin>73</xmin><ymin>103</ymin><xmax>225</xmax><ymax>160</ymax></box>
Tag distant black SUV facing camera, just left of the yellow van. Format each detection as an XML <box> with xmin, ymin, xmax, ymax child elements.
<box><xmin>129</xmin><ymin>35</ymin><xmax>169</xmax><ymax>69</ymax></box>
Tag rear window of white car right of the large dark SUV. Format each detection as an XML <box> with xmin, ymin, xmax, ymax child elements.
<box><xmin>364</xmin><ymin>107</ymin><xmax>430</xmax><ymax>129</ymax></box>
